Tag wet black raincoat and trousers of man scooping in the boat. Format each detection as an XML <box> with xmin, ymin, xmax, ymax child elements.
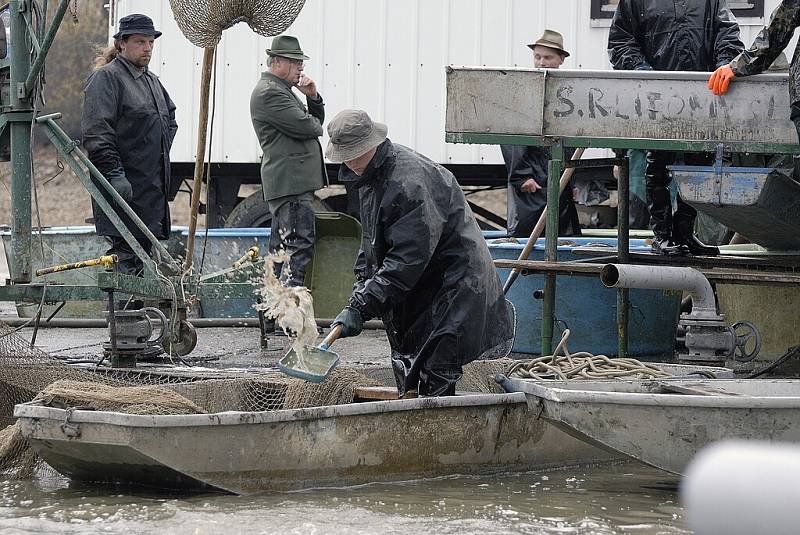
<box><xmin>340</xmin><ymin>140</ymin><xmax>513</xmax><ymax>396</ymax></box>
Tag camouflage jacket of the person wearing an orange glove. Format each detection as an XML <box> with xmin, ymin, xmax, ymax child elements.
<box><xmin>732</xmin><ymin>0</ymin><xmax>800</xmax><ymax>104</ymax></box>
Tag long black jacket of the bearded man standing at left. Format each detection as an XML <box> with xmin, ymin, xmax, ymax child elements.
<box><xmin>81</xmin><ymin>56</ymin><xmax>178</xmax><ymax>239</ymax></box>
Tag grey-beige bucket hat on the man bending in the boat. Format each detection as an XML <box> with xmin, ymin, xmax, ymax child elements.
<box><xmin>325</xmin><ymin>110</ymin><xmax>389</xmax><ymax>163</ymax></box>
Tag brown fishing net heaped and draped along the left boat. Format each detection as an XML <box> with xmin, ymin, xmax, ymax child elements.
<box><xmin>0</xmin><ymin>310</ymin><xmax>514</xmax><ymax>479</ymax></box>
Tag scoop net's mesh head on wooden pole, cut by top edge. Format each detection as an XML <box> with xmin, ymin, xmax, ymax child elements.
<box><xmin>169</xmin><ymin>0</ymin><xmax>305</xmax><ymax>48</ymax></box>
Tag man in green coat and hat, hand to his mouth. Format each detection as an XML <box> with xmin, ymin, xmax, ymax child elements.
<box><xmin>250</xmin><ymin>35</ymin><xmax>328</xmax><ymax>286</ymax></box>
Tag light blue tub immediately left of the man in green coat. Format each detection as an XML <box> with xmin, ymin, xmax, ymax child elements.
<box><xmin>183</xmin><ymin>228</ymin><xmax>270</xmax><ymax>318</ymax></box>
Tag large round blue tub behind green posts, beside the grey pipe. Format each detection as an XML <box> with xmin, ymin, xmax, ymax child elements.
<box><xmin>487</xmin><ymin>238</ymin><xmax>681</xmax><ymax>357</ymax></box>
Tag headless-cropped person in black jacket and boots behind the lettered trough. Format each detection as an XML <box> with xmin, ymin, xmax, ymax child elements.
<box><xmin>608</xmin><ymin>0</ymin><xmax>744</xmax><ymax>255</ymax></box>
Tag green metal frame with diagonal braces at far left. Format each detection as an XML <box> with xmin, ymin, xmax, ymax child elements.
<box><xmin>0</xmin><ymin>0</ymin><xmax>262</xmax><ymax>356</ymax></box>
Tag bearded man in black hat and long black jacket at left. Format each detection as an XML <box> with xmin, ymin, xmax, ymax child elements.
<box><xmin>81</xmin><ymin>14</ymin><xmax>178</xmax><ymax>275</ymax></box>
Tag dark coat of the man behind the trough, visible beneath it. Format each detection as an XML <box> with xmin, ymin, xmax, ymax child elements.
<box><xmin>500</xmin><ymin>145</ymin><xmax>581</xmax><ymax>238</ymax></box>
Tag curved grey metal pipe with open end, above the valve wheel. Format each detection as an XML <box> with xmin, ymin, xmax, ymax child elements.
<box><xmin>600</xmin><ymin>264</ymin><xmax>718</xmax><ymax>318</ymax></box>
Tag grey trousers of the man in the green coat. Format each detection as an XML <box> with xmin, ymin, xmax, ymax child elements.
<box><xmin>267</xmin><ymin>191</ymin><xmax>316</xmax><ymax>286</ymax></box>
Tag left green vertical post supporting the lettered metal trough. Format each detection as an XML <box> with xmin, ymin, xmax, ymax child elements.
<box><xmin>542</xmin><ymin>140</ymin><xmax>564</xmax><ymax>355</ymax></box>
